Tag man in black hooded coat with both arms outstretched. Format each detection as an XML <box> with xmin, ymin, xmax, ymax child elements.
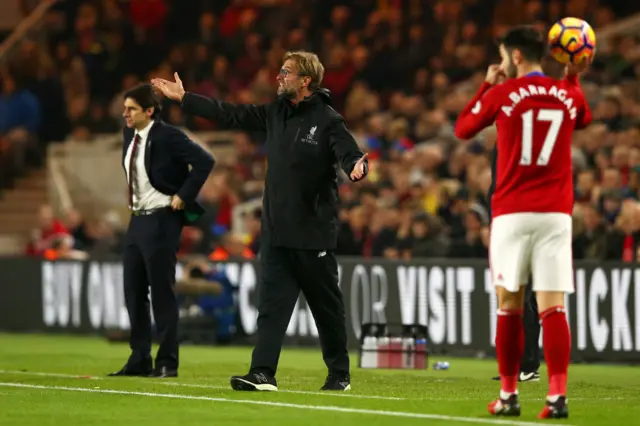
<box><xmin>152</xmin><ymin>52</ymin><xmax>368</xmax><ymax>391</ymax></box>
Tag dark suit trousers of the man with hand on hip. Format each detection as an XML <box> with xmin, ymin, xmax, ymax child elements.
<box><xmin>123</xmin><ymin>208</ymin><xmax>183</xmax><ymax>369</ymax></box>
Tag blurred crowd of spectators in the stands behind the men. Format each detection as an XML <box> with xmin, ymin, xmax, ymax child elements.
<box><xmin>7</xmin><ymin>0</ymin><xmax>640</xmax><ymax>261</ymax></box>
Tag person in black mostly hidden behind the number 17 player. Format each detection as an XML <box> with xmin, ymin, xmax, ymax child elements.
<box><xmin>487</xmin><ymin>148</ymin><xmax>540</xmax><ymax>382</ymax></box>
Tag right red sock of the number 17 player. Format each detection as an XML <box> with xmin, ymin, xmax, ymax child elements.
<box><xmin>540</xmin><ymin>306</ymin><xmax>571</xmax><ymax>397</ymax></box>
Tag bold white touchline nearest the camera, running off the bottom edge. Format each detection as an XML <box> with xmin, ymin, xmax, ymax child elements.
<box><xmin>0</xmin><ymin>382</ymin><xmax>571</xmax><ymax>426</ymax></box>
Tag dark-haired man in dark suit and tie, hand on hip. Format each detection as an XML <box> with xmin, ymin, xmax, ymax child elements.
<box><xmin>110</xmin><ymin>84</ymin><xmax>214</xmax><ymax>377</ymax></box>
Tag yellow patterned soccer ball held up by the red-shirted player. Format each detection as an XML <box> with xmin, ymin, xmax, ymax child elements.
<box><xmin>548</xmin><ymin>18</ymin><xmax>596</xmax><ymax>65</ymax></box>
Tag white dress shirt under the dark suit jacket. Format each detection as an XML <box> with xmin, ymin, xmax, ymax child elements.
<box><xmin>124</xmin><ymin>121</ymin><xmax>171</xmax><ymax>210</ymax></box>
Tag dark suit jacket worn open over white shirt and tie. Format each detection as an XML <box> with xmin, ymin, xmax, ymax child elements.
<box><xmin>122</xmin><ymin>119</ymin><xmax>215</xmax><ymax>222</ymax></box>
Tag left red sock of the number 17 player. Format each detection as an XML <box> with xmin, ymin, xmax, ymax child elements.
<box><xmin>496</xmin><ymin>309</ymin><xmax>524</xmax><ymax>393</ymax></box>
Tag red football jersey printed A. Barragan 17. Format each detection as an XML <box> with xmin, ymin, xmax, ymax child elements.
<box><xmin>455</xmin><ymin>73</ymin><xmax>591</xmax><ymax>217</ymax></box>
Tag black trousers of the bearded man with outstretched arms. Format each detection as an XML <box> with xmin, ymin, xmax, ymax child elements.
<box><xmin>251</xmin><ymin>244</ymin><xmax>349</xmax><ymax>376</ymax></box>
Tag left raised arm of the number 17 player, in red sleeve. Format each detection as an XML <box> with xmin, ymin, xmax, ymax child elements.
<box><xmin>455</xmin><ymin>65</ymin><xmax>500</xmax><ymax>139</ymax></box>
